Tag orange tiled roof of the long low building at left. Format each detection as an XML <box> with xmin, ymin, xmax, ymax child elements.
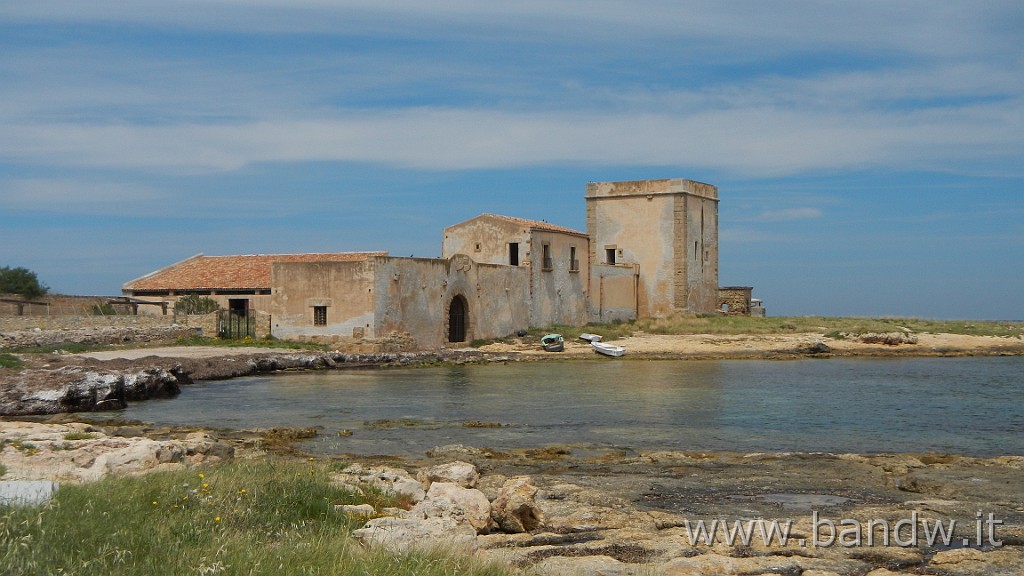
<box><xmin>123</xmin><ymin>252</ymin><xmax>387</xmax><ymax>291</ymax></box>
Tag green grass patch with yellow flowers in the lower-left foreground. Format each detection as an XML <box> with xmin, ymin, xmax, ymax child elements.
<box><xmin>0</xmin><ymin>460</ymin><xmax>513</xmax><ymax>576</ymax></box>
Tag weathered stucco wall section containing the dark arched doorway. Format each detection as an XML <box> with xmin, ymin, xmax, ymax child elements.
<box><xmin>375</xmin><ymin>254</ymin><xmax>529</xmax><ymax>348</ymax></box>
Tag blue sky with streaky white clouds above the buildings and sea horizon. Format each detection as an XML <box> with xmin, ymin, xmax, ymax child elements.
<box><xmin>0</xmin><ymin>0</ymin><xmax>1024</xmax><ymax>319</ymax></box>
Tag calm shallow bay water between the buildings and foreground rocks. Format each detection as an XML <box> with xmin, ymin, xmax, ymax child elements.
<box><xmin>114</xmin><ymin>357</ymin><xmax>1024</xmax><ymax>455</ymax></box>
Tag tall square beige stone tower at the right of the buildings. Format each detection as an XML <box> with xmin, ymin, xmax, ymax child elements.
<box><xmin>585</xmin><ymin>178</ymin><xmax>718</xmax><ymax>318</ymax></box>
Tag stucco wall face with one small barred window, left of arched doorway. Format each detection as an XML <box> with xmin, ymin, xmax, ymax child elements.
<box><xmin>270</xmin><ymin>259</ymin><xmax>375</xmax><ymax>338</ymax></box>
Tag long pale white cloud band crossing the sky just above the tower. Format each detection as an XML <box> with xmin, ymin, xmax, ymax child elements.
<box><xmin>0</xmin><ymin>96</ymin><xmax>1024</xmax><ymax>175</ymax></box>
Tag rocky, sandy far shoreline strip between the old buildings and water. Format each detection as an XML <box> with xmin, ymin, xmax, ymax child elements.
<box><xmin>0</xmin><ymin>333</ymin><xmax>1024</xmax><ymax>416</ymax></box>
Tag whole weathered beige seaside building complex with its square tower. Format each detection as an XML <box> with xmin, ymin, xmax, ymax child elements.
<box><xmin>123</xmin><ymin>179</ymin><xmax>752</xmax><ymax>348</ymax></box>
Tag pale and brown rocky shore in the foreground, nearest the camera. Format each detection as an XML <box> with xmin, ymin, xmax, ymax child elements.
<box><xmin>0</xmin><ymin>415</ymin><xmax>1024</xmax><ymax>576</ymax></box>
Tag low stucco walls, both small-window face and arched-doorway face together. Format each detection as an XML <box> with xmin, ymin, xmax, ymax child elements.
<box><xmin>272</xmin><ymin>255</ymin><xmax>529</xmax><ymax>349</ymax></box>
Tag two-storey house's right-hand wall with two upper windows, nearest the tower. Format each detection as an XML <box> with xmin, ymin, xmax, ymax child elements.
<box><xmin>530</xmin><ymin>231</ymin><xmax>590</xmax><ymax>326</ymax></box>
